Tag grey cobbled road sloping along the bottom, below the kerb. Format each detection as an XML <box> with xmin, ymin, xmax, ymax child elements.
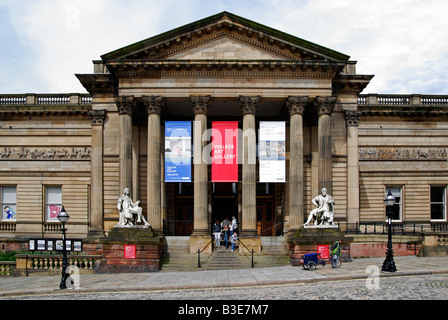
<box><xmin>3</xmin><ymin>274</ymin><xmax>448</xmax><ymax>303</ymax></box>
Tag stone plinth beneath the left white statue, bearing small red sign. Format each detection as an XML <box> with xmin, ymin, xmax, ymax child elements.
<box><xmin>99</xmin><ymin>226</ymin><xmax>164</xmax><ymax>273</ymax></box>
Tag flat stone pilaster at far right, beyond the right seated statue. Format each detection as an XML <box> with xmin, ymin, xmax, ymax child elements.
<box><xmin>345</xmin><ymin>111</ymin><xmax>361</xmax><ymax>223</ymax></box>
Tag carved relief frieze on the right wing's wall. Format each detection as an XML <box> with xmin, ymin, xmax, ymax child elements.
<box><xmin>359</xmin><ymin>147</ymin><xmax>448</xmax><ymax>160</ymax></box>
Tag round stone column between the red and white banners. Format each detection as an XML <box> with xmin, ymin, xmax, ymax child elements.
<box><xmin>239</xmin><ymin>96</ymin><xmax>260</xmax><ymax>241</ymax></box>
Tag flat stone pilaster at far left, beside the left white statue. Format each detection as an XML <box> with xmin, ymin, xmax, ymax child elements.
<box><xmin>89</xmin><ymin>110</ymin><xmax>106</xmax><ymax>236</ymax></box>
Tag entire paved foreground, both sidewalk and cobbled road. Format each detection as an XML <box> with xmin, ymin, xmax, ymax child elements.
<box><xmin>0</xmin><ymin>256</ymin><xmax>448</xmax><ymax>300</ymax></box>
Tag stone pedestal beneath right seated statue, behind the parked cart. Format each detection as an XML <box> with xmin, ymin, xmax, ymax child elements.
<box><xmin>287</xmin><ymin>226</ymin><xmax>353</xmax><ymax>266</ymax></box>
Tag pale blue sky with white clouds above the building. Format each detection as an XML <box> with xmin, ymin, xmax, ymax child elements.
<box><xmin>0</xmin><ymin>0</ymin><xmax>448</xmax><ymax>95</ymax></box>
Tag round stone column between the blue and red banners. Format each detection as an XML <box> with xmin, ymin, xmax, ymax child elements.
<box><xmin>190</xmin><ymin>95</ymin><xmax>211</xmax><ymax>253</ymax></box>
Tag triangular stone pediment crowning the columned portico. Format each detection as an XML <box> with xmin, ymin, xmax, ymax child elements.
<box><xmin>102</xmin><ymin>12</ymin><xmax>349</xmax><ymax>64</ymax></box>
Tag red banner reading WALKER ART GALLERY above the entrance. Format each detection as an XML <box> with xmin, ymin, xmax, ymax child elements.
<box><xmin>211</xmin><ymin>121</ymin><xmax>238</xmax><ymax>182</ymax></box>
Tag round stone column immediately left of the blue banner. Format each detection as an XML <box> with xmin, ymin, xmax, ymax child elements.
<box><xmin>142</xmin><ymin>96</ymin><xmax>165</xmax><ymax>231</ymax></box>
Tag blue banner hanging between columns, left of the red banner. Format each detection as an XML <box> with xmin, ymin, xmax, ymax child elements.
<box><xmin>165</xmin><ymin>121</ymin><xmax>191</xmax><ymax>182</ymax></box>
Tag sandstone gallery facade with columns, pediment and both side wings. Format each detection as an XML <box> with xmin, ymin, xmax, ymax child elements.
<box><xmin>0</xmin><ymin>12</ymin><xmax>448</xmax><ymax>252</ymax></box>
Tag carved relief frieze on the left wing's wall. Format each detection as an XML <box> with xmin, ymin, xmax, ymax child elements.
<box><xmin>0</xmin><ymin>147</ymin><xmax>91</xmax><ymax>160</ymax></box>
